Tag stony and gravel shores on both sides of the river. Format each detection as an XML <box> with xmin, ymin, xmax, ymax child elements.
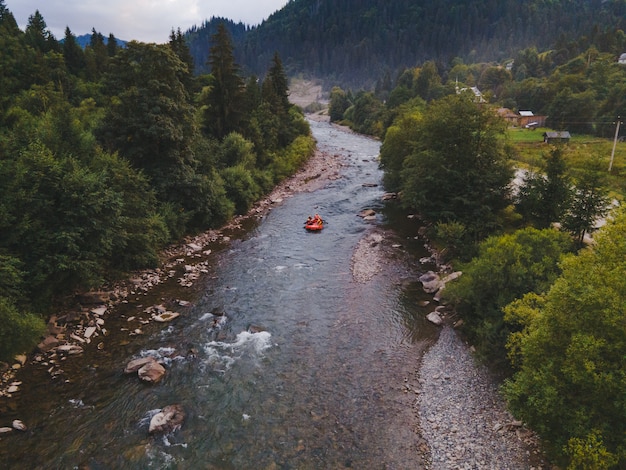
<box><xmin>0</xmin><ymin>117</ymin><xmax>547</xmax><ymax>469</ymax></box>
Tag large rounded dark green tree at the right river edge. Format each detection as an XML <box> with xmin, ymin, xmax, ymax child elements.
<box><xmin>401</xmin><ymin>94</ymin><xmax>513</xmax><ymax>240</ymax></box>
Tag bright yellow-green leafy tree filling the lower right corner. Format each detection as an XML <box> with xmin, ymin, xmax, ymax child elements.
<box><xmin>504</xmin><ymin>213</ymin><xmax>626</xmax><ymax>468</ymax></box>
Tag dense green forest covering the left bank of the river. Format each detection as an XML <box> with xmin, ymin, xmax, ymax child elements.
<box><xmin>0</xmin><ymin>0</ymin><xmax>314</xmax><ymax>360</ymax></box>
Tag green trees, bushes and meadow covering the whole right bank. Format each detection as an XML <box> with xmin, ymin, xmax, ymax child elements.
<box><xmin>329</xmin><ymin>26</ymin><xmax>626</xmax><ymax>470</ymax></box>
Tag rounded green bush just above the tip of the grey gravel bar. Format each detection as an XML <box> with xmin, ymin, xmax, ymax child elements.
<box><xmin>443</xmin><ymin>228</ymin><xmax>571</xmax><ymax>366</ymax></box>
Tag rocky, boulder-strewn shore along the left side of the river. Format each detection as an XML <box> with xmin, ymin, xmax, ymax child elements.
<box><xmin>0</xmin><ymin>114</ymin><xmax>344</xmax><ymax>398</ymax></box>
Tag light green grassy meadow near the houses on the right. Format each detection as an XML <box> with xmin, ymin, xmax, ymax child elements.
<box><xmin>507</xmin><ymin>128</ymin><xmax>626</xmax><ymax>200</ymax></box>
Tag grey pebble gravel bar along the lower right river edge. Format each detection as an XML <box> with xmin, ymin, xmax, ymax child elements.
<box><xmin>417</xmin><ymin>326</ymin><xmax>548</xmax><ymax>470</ymax></box>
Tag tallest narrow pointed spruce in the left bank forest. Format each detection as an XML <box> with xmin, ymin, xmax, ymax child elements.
<box><xmin>204</xmin><ymin>24</ymin><xmax>245</xmax><ymax>140</ymax></box>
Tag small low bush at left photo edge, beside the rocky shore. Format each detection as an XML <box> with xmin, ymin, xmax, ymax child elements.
<box><xmin>0</xmin><ymin>296</ymin><xmax>46</xmax><ymax>361</ymax></box>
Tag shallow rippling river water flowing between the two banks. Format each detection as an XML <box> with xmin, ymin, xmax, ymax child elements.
<box><xmin>0</xmin><ymin>121</ymin><xmax>436</xmax><ymax>469</ymax></box>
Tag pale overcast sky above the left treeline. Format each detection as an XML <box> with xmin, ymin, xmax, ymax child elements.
<box><xmin>4</xmin><ymin>0</ymin><xmax>288</xmax><ymax>43</ymax></box>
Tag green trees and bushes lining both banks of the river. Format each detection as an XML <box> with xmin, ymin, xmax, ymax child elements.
<box><xmin>0</xmin><ymin>0</ymin><xmax>626</xmax><ymax>469</ymax></box>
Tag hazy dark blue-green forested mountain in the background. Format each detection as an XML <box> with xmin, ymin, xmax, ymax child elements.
<box><xmin>187</xmin><ymin>0</ymin><xmax>626</xmax><ymax>86</ymax></box>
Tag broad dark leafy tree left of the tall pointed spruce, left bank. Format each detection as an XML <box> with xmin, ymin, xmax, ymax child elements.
<box><xmin>98</xmin><ymin>41</ymin><xmax>195</xmax><ymax>184</ymax></box>
